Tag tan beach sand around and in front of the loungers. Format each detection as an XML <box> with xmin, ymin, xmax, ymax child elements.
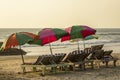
<box><xmin>0</xmin><ymin>54</ymin><xmax>120</xmax><ymax>80</ymax></box>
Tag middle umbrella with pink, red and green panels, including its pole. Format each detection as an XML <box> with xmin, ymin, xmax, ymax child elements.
<box><xmin>38</xmin><ymin>28</ymin><xmax>68</xmax><ymax>54</ymax></box>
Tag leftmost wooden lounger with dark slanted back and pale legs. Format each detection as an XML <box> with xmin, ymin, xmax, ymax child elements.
<box><xmin>21</xmin><ymin>54</ymin><xmax>71</xmax><ymax>75</ymax></box>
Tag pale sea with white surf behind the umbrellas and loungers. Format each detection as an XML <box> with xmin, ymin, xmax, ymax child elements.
<box><xmin>0</xmin><ymin>28</ymin><xmax>120</xmax><ymax>55</ymax></box>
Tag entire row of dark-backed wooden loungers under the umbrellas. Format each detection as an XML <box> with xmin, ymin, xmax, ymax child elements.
<box><xmin>21</xmin><ymin>45</ymin><xmax>118</xmax><ymax>75</ymax></box>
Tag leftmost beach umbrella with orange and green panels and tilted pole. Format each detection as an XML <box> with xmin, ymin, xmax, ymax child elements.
<box><xmin>1</xmin><ymin>32</ymin><xmax>38</xmax><ymax>63</ymax></box>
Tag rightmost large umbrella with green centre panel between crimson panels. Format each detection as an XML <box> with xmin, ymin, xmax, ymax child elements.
<box><xmin>61</xmin><ymin>25</ymin><xmax>96</xmax><ymax>50</ymax></box>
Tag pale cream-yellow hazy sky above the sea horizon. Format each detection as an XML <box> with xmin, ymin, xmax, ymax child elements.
<box><xmin>0</xmin><ymin>0</ymin><xmax>120</xmax><ymax>28</ymax></box>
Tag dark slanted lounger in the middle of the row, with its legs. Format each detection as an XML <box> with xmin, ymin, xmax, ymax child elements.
<box><xmin>63</xmin><ymin>48</ymin><xmax>93</xmax><ymax>70</ymax></box>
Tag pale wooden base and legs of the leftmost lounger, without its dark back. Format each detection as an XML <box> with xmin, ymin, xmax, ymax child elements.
<box><xmin>21</xmin><ymin>63</ymin><xmax>73</xmax><ymax>76</ymax></box>
